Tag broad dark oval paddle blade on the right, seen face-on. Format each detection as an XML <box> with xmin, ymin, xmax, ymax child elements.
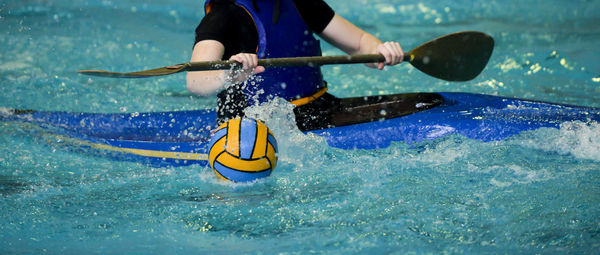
<box><xmin>409</xmin><ymin>31</ymin><xmax>494</xmax><ymax>81</ymax></box>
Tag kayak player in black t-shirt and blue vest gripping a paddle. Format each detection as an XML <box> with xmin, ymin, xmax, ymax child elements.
<box><xmin>186</xmin><ymin>0</ymin><xmax>404</xmax><ymax>130</ymax></box>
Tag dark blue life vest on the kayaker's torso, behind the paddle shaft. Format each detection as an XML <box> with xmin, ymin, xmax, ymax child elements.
<box><xmin>205</xmin><ymin>0</ymin><xmax>326</xmax><ymax>105</ymax></box>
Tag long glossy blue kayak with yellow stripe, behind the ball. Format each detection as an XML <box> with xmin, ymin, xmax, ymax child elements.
<box><xmin>2</xmin><ymin>93</ymin><xmax>600</xmax><ymax>166</ymax></box>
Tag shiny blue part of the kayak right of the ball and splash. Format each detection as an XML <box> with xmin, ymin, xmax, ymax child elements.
<box><xmin>315</xmin><ymin>93</ymin><xmax>600</xmax><ymax>149</ymax></box>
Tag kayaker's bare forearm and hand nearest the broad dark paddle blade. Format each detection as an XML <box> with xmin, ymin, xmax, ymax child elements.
<box><xmin>319</xmin><ymin>14</ymin><xmax>404</xmax><ymax>70</ymax></box>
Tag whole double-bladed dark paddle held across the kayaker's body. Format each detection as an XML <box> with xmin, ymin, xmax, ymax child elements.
<box><xmin>78</xmin><ymin>31</ymin><xmax>494</xmax><ymax>81</ymax></box>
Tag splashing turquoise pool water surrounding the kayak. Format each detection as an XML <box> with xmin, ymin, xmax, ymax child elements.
<box><xmin>0</xmin><ymin>0</ymin><xmax>600</xmax><ymax>254</ymax></box>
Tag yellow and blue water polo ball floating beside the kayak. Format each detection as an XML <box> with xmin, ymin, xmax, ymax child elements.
<box><xmin>208</xmin><ymin>117</ymin><xmax>277</xmax><ymax>182</ymax></box>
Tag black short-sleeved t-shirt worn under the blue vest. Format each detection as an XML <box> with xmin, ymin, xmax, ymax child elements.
<box><xmin>194</xmin><ymin>0</ymin><xmax>335</xmax><ymax>59</ymax></box>
